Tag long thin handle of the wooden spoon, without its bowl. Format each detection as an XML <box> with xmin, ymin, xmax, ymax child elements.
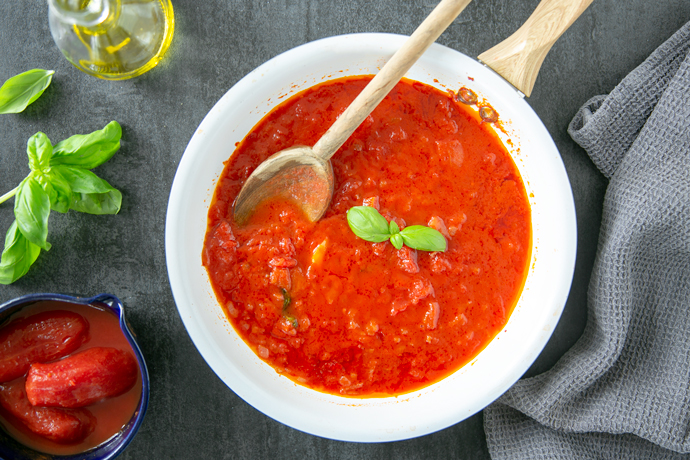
<box><xmin>313</xmin><ymin>0</ymin><xmax>471</xmax><ymax>160</ymax></box>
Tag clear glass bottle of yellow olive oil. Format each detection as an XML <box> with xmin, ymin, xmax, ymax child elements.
<box><xmin>48</xmin><ymin>0</ymin><xmax>175</xmax><ymax>80</ymax></box>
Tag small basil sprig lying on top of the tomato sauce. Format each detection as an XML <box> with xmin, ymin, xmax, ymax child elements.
<box><xmin>347</xmin><ymin>206</ymin><xmax>448</xmax><ymax>252</ymax></box>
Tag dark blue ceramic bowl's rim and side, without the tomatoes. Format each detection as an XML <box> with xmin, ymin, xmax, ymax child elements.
<box><xmin>0</xmin><ymin>294</ymin><xmax>149</xmax><ymax>460</ymax></box>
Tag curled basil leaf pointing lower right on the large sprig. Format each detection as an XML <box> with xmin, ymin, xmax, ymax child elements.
<box><xmin>52</xmin><ymin>165</ymin><xmax>122</xmax><ymax>214</ymax></box>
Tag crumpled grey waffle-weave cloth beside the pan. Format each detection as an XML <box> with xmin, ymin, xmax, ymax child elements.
<box><xmin>484</xmin><ymin>22</ymin><xmax>690</xmax><ymax>460</ymax></box>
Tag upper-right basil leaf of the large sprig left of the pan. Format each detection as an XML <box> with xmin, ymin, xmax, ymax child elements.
<box><xmin>50</xmin><ymin>121</ymin><xmax>122</xmax><ymax>169</ymax></box>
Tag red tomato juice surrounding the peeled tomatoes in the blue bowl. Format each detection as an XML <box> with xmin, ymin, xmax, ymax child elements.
<box><xmin>0</xmin><ymin>301</ymin><xmax>142</xmax><ymax>455</ymax></box>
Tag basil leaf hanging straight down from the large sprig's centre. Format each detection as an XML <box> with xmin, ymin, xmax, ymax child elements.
<box><xmin>14</xmin><ymin>175</ymin><xmax>50</xmax><ymax>251</ymax></box>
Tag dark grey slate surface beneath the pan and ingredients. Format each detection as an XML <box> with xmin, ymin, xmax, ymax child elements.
<box><xmin>0</xmin><ymin>0</ymin><xmax>690</xmax><ymax>459</ymax></box>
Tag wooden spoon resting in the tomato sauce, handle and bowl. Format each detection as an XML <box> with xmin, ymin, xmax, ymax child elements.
<box><xmin>234</xmin><ymin>0</ymin><xmax>471</xmax><ymax>225</ymax></box>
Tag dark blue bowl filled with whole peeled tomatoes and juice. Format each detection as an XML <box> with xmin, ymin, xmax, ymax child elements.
<box><xmin>0</xmin><ymin>294</ymin><xmax>149</xmax><ymax>460</ymax></box>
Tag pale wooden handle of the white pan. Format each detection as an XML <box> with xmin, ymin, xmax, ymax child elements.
<box><xmin>479</xmin><ymin>0</ymin><xmax>593</xmax><ymax>97</ymax></box>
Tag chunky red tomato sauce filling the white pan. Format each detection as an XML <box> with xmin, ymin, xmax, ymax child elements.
<box><xmin>202</xmin><ymin>77</ymin><xmax>531</xmax><ymax>397</ymax></box>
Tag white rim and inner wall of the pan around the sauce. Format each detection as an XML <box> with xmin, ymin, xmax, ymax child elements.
<box><xmin>166</xmin><ymin>34</ymin><xmax>575</xmax><ymax>442</ymax></box>
